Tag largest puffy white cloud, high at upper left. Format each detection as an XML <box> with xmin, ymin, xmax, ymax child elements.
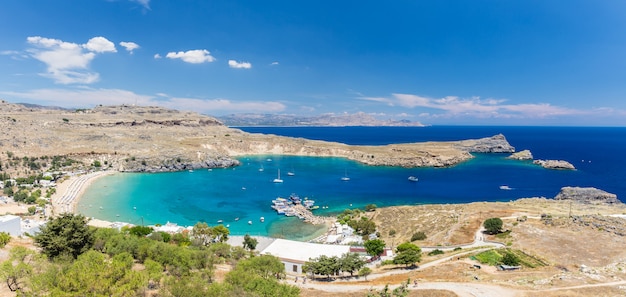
<box><xmin>26</xmin><ymin>36</ymin><xmax>116</xmax><ymax>84</ymax></box>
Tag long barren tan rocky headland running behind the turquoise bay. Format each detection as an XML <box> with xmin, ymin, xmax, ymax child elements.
<box><xmin>0</xmin><ymin>101</ymin><xmax>515</xmax><ymax>173</ymax></box>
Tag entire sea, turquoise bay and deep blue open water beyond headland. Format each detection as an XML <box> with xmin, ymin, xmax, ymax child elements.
<box><xmin>77</xmin><ymin>126</ymin><xmax>626</xmax><ymax>240</ymax></box>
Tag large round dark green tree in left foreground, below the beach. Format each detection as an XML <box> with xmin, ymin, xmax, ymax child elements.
<box><xmin>34</xmin><ymin>213</ymin><xmax>94</xmax><ymax>258</ymax></box>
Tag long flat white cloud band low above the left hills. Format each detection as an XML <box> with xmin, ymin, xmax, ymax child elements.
<box><xmin>0</xmin><ymin>87</ymin><xmax>286</xmax><ymax>114</ymax></box>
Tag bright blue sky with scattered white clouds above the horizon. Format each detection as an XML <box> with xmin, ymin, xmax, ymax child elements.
<box><xmin>0</xmin><ymin>0</ymin><xmax>626</xmax><ymax>126</ymax></box>
